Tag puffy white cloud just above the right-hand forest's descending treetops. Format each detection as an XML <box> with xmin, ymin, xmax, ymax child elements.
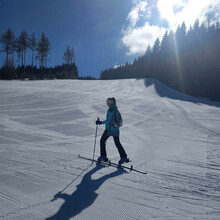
<box><xmin>122</xmin><ymin>22</ymin><xmax>165</xmax><ymax>55</ymax></box>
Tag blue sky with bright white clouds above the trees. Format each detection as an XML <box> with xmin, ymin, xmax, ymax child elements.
<box><xmin>0</xmin><ymin>0</ymin><xmax>220</xmax><ymax>78</ymax></box>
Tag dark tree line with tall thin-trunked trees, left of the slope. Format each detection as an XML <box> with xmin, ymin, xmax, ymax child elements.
<box><xmin>0</xmin><ymin>29</ymin><xmax>78</xmax><ymax>79</ymax></box>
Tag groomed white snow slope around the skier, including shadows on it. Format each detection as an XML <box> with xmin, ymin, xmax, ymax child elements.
<box><xmin>0</xmin><ymin>79</ymin><xmax>220</xmax><ymax>220</ymax></box>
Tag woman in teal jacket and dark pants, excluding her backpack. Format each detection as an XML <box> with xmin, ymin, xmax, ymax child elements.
<box><xmin>96</xmin><ymin>97</ymin><xmax>129</xmax><ymax>165</ymax></box>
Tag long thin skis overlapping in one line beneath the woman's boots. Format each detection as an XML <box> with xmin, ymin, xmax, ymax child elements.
<box><xmin>78</xmin><ymin>154</ymin><xmax>147</xmax><ymax>174</ymax></box>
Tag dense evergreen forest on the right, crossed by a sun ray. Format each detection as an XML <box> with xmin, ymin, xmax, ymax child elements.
<box><xmin>100</xmin><ymin>20</ymin><xmax>220</xmax><ymax>101</ymax></box>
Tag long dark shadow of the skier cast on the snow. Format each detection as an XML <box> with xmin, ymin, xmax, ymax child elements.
<box><xmin>46</xmin><ymin>164</ymin><xmax>125</xmax><ymax>220</ymax></box>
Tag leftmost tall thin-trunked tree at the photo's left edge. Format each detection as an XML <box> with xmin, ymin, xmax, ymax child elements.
<box><xmin>0</xmin><ymin>29</ymin><xmax>15</xmax><ymax>67</ymax></box>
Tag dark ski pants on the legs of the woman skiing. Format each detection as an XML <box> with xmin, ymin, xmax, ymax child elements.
<box><xmin>100</xmin><ymin>130</ymin><xmax>127</xmax><ymax>158</ymax></box>
